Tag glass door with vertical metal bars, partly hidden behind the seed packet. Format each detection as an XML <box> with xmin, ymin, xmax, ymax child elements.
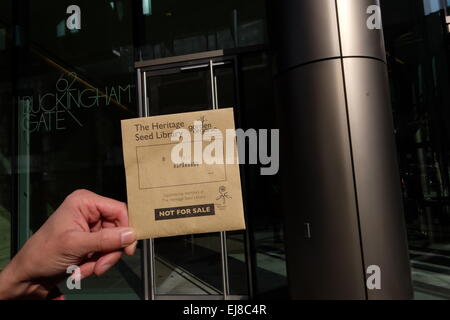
<box><xmin>138</xmin><ymin>53</ymin><xmax>249</xmax><ymax>299</ymax></box>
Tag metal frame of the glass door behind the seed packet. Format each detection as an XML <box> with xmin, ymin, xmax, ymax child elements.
<box><xmin>135</xmin><ymin>50</ymin><xmax>255</xmax><ymax>300</ymax></box>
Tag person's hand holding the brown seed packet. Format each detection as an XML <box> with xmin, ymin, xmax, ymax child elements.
<box><xmin>0</xmin><ymin>190</ymin><xmax>137</xmax><ymax>299</ymax></box>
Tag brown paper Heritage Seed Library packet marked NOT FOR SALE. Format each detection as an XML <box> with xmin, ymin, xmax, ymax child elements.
<box><xmin>122</xmin><ymin>108</ymin><xmax>245</xmax><ymax>239</ymax></box>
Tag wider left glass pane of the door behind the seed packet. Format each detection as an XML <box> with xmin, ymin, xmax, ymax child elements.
<box><xmin>147</xmin><ymin>65</ymin><xmax>222</xmax><ymax>295</ymax></box>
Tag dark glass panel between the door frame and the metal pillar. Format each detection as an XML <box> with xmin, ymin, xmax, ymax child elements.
<box><xmin>240</xmin><ymin>53</ymin><xmax>288</xmax><ymax>299</ymax></box>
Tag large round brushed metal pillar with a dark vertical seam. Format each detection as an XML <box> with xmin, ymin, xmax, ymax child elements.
<box><xmin>274</xmin><ymin>0</ymin><xmax>412</xmax><ymax>299</ymax></box>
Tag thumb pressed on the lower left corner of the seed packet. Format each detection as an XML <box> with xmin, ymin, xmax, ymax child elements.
<box><xmin>74</xmin><ymin>227</ymin><xmax>136</xmax><ymax>254</ymax></box>
